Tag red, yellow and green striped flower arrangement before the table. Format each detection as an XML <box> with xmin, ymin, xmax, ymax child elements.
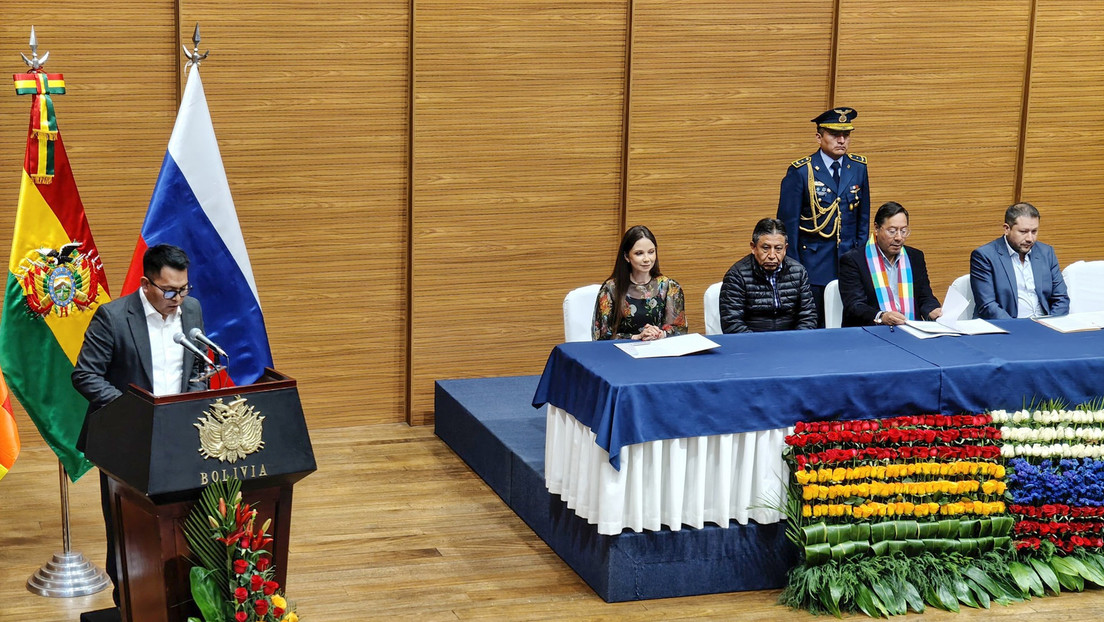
<box><xmin>781</xmin><ymin>414</ymin><xmax>1023</xmax><ymax>616</ymax></box>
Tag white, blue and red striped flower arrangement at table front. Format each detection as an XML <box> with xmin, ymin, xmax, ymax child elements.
<box><xmin>991</xmin><ymin>401</ymin><xmax>1104</xmax><ymax>595</ymax></box>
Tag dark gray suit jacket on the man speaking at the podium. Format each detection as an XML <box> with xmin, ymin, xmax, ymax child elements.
<box><xmin>72</xmin><ymin>289</ymin><xmax>204</xmax><ymax>451</ymax></box>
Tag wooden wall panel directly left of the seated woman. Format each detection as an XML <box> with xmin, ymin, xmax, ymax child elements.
<box><xmin>410</xmin><ymin>0</ymin><xmax>627</xmax><ymax>423</ymax></box>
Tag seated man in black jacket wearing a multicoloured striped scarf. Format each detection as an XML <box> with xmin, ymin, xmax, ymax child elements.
<box><xmin>839</xmin><ymin>201</ymin><xmax>943</xmax><ymax>326</ymax></box>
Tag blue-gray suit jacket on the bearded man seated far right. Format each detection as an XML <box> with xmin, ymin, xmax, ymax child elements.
<box><xmin>969</xmin><ymin>235</ymin><xmax>1070</xmax><ymax>319</ymax></box>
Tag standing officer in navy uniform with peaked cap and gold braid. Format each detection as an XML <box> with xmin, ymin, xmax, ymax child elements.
<box><xmin>777</xmin><ymin>108</ymin><xmax>870</xmax><ymax>328</ymax></box>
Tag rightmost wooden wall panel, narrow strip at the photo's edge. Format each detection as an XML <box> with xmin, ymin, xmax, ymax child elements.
<box><xmin>1020</xmin><ymin>0</ymin><xmax>1104</xmax><ymax>267</ymax></box>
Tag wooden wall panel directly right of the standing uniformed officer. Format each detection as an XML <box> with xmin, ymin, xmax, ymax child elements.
<box><xmin>836</xmin><ymin>0</ymin><xmax>1031</xmax><ymax>301</ymax></box>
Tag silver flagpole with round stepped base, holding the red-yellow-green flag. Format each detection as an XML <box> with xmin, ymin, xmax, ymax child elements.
<box><xmin>12</xmin><ymin>25</ymin><xmax>110</xmax><ymax>598</ymax></box>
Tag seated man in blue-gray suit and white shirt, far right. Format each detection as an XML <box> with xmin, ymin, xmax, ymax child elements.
<box><xmin>969</xmin><ymin>203</ymin><xmax>1070</xmax><ymax>319</ymax></box>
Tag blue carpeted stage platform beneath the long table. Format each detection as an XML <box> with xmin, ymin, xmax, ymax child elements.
<box><xmin>435</xmin><ymin>376</ymin><xmax>797</xmax><ymax>602</ymax></box>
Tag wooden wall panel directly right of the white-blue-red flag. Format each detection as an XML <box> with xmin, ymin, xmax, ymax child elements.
<box><xmin>178</xmin><ymin>0</ymin><xmax>410</xmax><ymax>428</ymax></box>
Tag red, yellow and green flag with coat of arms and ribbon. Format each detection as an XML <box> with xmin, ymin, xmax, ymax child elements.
<box><xmin>0</xmin><ymin>70</ymin><xmax>109</xmax><ymax>482</ymax></box>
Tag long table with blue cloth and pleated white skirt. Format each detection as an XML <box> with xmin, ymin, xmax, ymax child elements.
<box><xmin>533</xmin><ymin>319</ymin><xmax>1104</xmax><ymax>534</ymax></box>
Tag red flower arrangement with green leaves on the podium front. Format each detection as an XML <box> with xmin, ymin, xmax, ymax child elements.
<box><xmin>184</xmin><ymin>478</ymin><xmax>299</xmax><ymax>622</ymax></box>
